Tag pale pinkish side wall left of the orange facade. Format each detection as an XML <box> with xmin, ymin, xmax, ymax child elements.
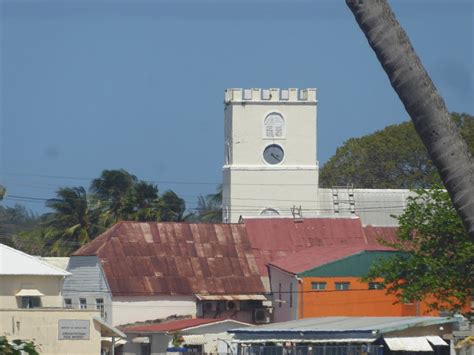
<box><xmin>269</xmin><ymin>266</ymin><xmax>299</xmax><ymax>322</ymax></box>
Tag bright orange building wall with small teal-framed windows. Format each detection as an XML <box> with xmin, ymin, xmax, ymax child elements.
<box><xmin>298</xmin><ymin>277</ymin><xmax>439</xmax><ymax>318</ymax></box>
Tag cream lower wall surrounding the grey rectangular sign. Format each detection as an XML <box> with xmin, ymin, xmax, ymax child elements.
<box><xmin>0</xmin><ymin>308</ymin><xmax>101</xmax><ymax>355</ymax></box>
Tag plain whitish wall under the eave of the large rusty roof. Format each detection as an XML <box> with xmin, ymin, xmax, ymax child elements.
<box><xmin>112</xmin><ymin>295</ymin><xmax>197</xmax><ymax>326</ymax></box>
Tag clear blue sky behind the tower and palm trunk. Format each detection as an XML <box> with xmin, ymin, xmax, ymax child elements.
<box><xmin>0</xmin><ymin>0</ymin><xmax>474</xmax><ymax>212</ymax></box>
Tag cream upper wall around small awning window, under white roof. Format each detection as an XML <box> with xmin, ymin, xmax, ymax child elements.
<box><xmin>0</xmin><ymin>275</ymin><xmax>63</xmax><ymax>309</ymax></box>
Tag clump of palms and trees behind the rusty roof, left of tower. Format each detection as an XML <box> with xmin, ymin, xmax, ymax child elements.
<box><xmin>5</xmin><ymin>170</ymin><xmax>186</xmax><ymax>256</ymax></box>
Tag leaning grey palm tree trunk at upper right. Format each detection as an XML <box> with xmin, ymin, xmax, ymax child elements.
<box><xmin>346</xmin><ymin>0</ymin><xmax>474</xmax><ymax>239</ymax></box>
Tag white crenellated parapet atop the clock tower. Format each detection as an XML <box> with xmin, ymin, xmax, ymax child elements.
<box><xmin>225</xmin><ymin>88</ymin><xmax>317</xmax><ymax>103</ymax></box>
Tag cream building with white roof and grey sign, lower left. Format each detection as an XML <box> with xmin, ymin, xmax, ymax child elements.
<box><xmin>0</xmin><ymin>244</ymin><xmax>125</xmax><ymax>355</ymax></box>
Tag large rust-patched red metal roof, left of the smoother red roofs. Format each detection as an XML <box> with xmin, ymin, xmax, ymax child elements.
<box><xmin>73</xmin><ymin>222</ymin><xmax>265</xmax><ymax>296</ymax></box>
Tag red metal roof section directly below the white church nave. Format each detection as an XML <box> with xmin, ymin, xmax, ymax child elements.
<box><xmin>244</xmin><ymin>218</ymin><xmax>368</xmax><ymax>276</ymax></box>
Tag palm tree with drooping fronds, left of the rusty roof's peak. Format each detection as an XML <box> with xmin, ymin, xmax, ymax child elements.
<box><xmin>43</xmin><ymin>187</ymin><xmax>103</xmax><ymax>256</ymax></box>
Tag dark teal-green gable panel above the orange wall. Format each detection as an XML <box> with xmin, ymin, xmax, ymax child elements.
<box><xmin>298</xmin><ymin>251</ymin><xmax>403</xmax><ymax>277</ymax></box>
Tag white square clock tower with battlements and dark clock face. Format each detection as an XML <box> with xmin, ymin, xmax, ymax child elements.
<box><xmin>222</xmin><ymin>88</ymin><xmax>318</xmax><ymax>222</ymax></box>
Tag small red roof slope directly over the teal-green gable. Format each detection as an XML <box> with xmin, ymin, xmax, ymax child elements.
<box><xmin>270</xmin><ymin>245</ymin><xmax>394</xmax><ymax>274</ymax></box>
